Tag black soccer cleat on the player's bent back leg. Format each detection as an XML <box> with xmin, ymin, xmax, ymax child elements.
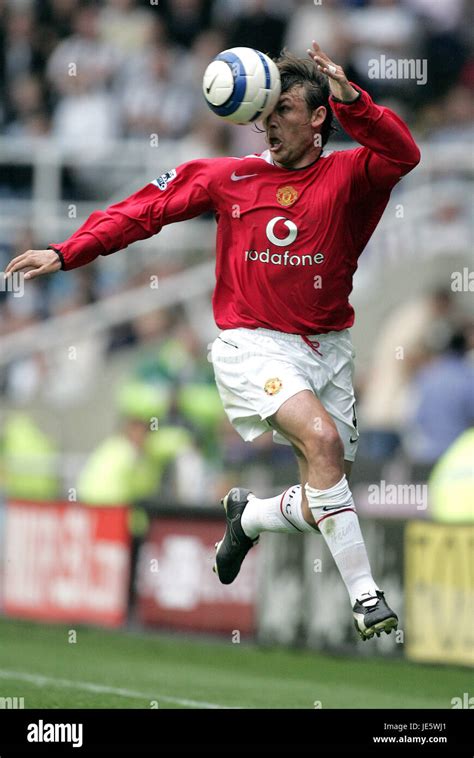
<box><xmin>213</xmin><ymin>487</ymin><xmax>258</xmax><ymax>584</ymax></box>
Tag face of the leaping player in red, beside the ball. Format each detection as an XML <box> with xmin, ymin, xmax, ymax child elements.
<box><xmin>264</xmin><ymin>85</ymin><xmax>326</xmax><ymax>168</ymax></box>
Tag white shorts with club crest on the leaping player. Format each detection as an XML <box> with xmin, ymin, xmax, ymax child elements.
<box><xmin>211</xmin><ymin>328</ymin><xmax>359</xmax><ymax>461</ymax></box>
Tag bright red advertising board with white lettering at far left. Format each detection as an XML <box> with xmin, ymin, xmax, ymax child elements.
<box><xmin>1</xmin><ymin>501</ymin><xmax>129</xmax><ymax>626</ymax></box>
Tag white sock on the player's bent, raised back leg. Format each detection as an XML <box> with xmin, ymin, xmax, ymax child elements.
<box><xmin>241</xmin><ymin>484</ymin><xmax>316</xmax><ymax>539</ymax></box>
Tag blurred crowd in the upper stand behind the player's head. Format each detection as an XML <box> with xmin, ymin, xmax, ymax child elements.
<box><xmin>0</xmin><ymin>0</ymin><xmax>474</xmax><ymax>154</ymax></box>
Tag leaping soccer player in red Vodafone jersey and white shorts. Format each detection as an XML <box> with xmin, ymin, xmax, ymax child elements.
<box><xmin>6</xmin><ymin>42</ymin><xmax>420</xmax><ymax>639</ymax></box>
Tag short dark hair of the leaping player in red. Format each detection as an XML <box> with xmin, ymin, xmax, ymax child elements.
<box><xmin>275</xmin><ymin>48</ymin><xmax>336</xmax><ymax>146</ymax></box>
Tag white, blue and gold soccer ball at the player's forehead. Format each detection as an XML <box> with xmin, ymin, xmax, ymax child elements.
<box><xmin>202</xmin><ymin>47</ymin><xmax>281</xmax><ymax>124</ymax></box>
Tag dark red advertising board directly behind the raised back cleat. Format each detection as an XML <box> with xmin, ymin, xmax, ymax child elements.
<box><xmin>138</xmin><ymin>517</ymin><xmax>258</xmax><ymax>634</ymax></box>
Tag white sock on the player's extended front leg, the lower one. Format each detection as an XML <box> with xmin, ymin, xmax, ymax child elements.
<box><xmin>305</xmin><ymin>474</ymin><xmax>379</xmax><ymax>605</ymax></box>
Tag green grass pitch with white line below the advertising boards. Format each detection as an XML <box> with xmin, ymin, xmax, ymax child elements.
<box><xmin>0</xmin><ymin>618</ymin><xmax>472</xmax><ymax>709</ymax></box>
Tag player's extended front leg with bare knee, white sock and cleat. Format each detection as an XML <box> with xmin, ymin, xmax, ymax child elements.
<box><xmin>271</xmin><ymin>391</ymin><xmax>398</xmax><ymax>639</ymax></box>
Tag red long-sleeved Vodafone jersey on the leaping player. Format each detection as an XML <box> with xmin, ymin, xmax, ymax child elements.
<box><xmin>52</xmin><ymin>87</ymin><xmax>420</xmax><ymax>334</ymax></box>
